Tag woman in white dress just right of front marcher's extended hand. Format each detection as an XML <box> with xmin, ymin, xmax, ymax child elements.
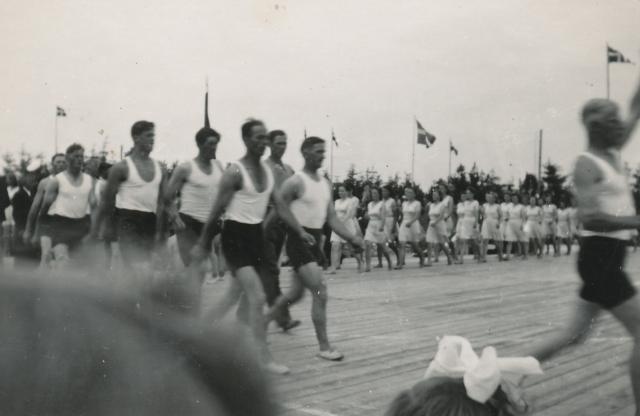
<box><xmin>364</xmin><ymin>188</ymin><xmax>392</xmax><ymax>272</ymax></box>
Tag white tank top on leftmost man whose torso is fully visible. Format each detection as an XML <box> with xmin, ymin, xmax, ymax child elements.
<box><xmin>48</xmin><ymin>172</ymin><xmax>93</xmax><ymax>218</ymax></box>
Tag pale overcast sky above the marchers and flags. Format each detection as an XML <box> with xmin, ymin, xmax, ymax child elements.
<box><xmin>0</xmin><ymin>0</ymin><xmax>640</xmax><ymax>184</ymax></box>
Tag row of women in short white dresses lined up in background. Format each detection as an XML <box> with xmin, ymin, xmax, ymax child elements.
<box><xmin>329</xmin><ymin>185</ymin><xmax>580</xmax><ymax>274</ymax></box>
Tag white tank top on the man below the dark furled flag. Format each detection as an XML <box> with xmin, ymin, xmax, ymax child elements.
<box><xmin>180</xmin><ymin>160</ymin><xmax>223</xmax><ymax>222</ymax></box>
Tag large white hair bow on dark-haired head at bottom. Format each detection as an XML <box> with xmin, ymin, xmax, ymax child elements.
<box><xmin>424</xmin><ymin>335</ymin><xmax>542</xmax><ymax>403</ymax></box>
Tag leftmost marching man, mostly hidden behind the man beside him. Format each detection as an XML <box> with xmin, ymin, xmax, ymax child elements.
<box><xmin>22</xmin><ymin>153</ymin><xmax>67</xmax><ymax>268</ymax></box>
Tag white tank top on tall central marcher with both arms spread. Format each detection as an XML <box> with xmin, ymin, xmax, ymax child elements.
<box><xmin>225</xmin><ymin>161</ymin><xmax>273</xmax><ymax>224</ymax></box>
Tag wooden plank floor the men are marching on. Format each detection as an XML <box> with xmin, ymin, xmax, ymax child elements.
<box><xmin>202</xmin><ymin>250</ymin><xmax>640</xmax><ymax>416</ymax></box>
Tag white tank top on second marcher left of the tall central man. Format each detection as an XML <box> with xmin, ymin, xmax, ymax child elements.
<box><xmin>116</xmin><ymin>156</ymin><xmax>162</xmax><ymax>214</ymax></box>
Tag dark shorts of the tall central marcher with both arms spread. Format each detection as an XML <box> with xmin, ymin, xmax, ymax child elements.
<box><xmin>221</xmin><ymin>220</ymin><xmax>265</xmax><ymax>270</ymax></box>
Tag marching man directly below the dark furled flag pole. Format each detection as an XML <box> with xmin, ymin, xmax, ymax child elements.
<box><xmin>164</xmin><ymin>127</ymin><xmax>224</xmax><ymax>266</ymax></box>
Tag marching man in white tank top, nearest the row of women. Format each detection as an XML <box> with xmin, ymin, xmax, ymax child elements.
<box><xmin>267</xmin><ymin>137</ymin><xmax>364</xmax><ymax>361</ymax></box>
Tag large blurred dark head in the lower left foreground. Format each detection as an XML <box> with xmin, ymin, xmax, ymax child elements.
<box><xmin>0</xmin><ymin>273</ymin><xmax>275</xmax><ymax>416</ymax></box>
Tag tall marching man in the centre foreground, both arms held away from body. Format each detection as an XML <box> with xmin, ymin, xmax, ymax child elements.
<box><xmin>191</xmin><ymin>120</ymin><xmax>314</xmax><ymax>374</ymax></box>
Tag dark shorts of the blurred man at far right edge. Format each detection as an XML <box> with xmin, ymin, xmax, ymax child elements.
<box><xmin>578</xmin><ymin>237</ymin><xmax>636</xmax><ymax>309</ymax></box>
